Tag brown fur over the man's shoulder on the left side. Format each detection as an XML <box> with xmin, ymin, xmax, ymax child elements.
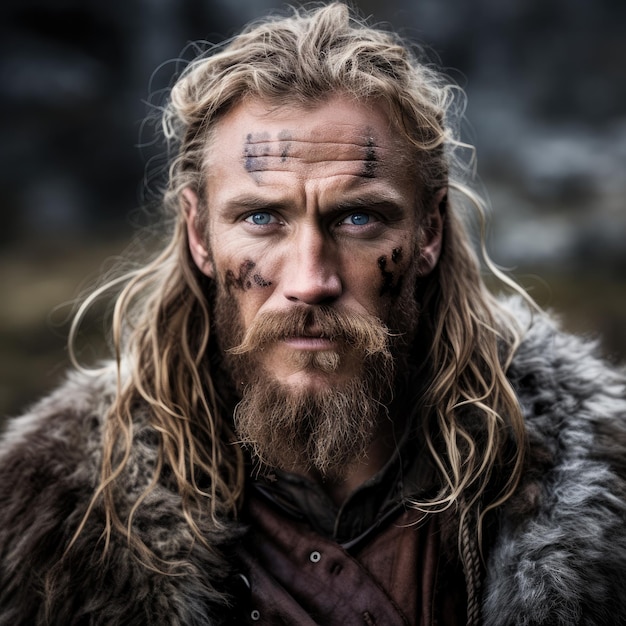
<box><xmin>0</xmin><ymin>364</ymin><xmax>231</xmax><ymax>624</ymax></box>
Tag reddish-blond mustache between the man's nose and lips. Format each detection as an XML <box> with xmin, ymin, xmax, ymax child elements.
<box><xmin>228</xmin><ymin>306</ymin><xmax>393</xmax><ymax>356</ymax></box>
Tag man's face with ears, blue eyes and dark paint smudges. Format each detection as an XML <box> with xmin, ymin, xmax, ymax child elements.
<box><xmin>185</xmin><ymin>97</ymin><xmax>440</xmax><ymax>472</ymax></box>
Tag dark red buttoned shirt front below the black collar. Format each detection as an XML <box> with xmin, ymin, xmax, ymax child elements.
<box><xmin>229</xmin><ymin>492</ymin><xmax>466</xmax><ymax>626</ymax></box>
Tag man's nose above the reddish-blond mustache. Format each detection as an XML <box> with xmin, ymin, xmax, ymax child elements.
<box><xmin>283</xmin><ymin>226</ymin><xmax>343</xmax><ymax>304</ymax></box>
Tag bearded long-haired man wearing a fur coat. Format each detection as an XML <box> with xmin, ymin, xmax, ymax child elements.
<box><xmin>0</xmin><ymin>4</ymin><xmax>626</xmax><ymax>625</ymax></box>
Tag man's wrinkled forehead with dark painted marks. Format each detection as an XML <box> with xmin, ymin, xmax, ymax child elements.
<box><xmin>208</xmin><ymin>96</ymin><xmax>408</xmax><ymax>184</ymax></box>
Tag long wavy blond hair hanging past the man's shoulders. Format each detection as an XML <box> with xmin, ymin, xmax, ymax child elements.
<box><xmin>70</xmin><ymin>3</ymin><xmax>525</xmax><ymax>572</ymax></box>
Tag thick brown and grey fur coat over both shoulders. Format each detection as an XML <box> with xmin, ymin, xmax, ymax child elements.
<box><xmin>0</xmin><ymin>303</ymin><xmax>626</xmax><ymax>626</ymax></box>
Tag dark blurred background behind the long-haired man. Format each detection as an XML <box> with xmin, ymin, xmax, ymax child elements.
<box><xmin>0</xmin><ymin>0</ymin><xmax>626</xmax><ymax>416</ymax></box>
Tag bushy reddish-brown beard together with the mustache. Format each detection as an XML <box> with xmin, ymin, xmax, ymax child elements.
<box><xmin>215</xmin><ymin>278</ymin><xmax>417</xmax><ymax>480</ymax></box>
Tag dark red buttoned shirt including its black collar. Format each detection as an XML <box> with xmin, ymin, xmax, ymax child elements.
<box><xmin>232</xmin><ymin>432</ymin><xmax>466</xmax><ymax>626</ymax></box>
